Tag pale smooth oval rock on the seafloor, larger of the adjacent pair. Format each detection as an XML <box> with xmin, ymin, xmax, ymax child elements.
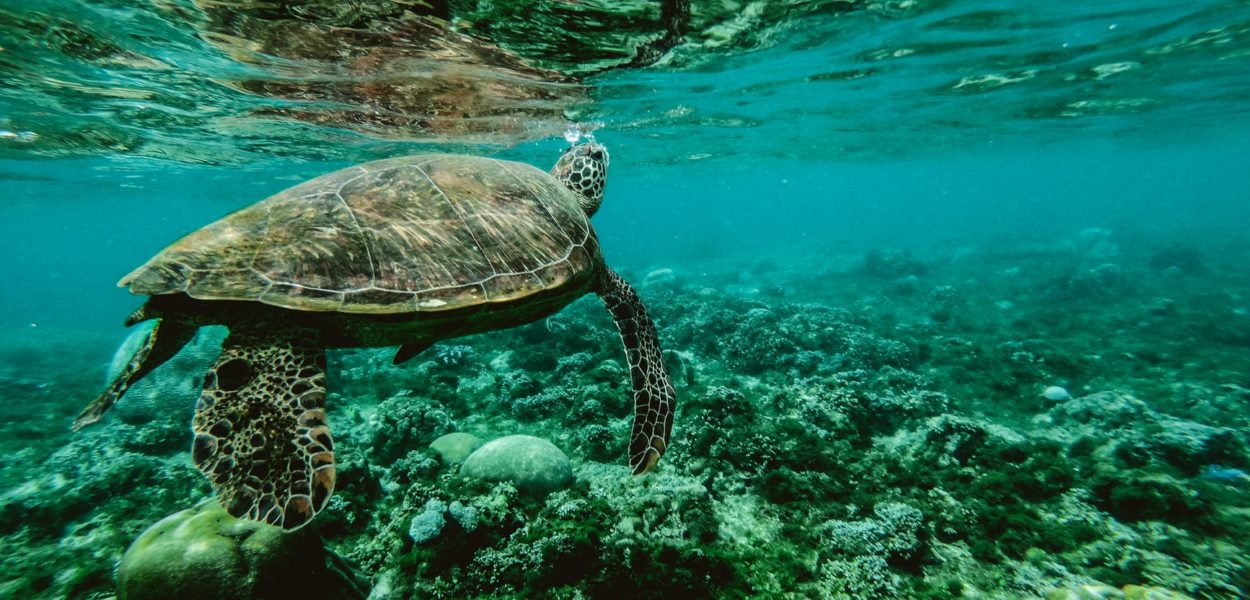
<box><xmin>460</xmin><ymin>435</ymin><xmax>573</xmax><ymax>498</ymax></box>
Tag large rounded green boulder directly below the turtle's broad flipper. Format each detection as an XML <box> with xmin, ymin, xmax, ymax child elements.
<box><xmin>118</xmin><ymin>501</ymin><xmax>368</xmax><ymax>600</ymax></box>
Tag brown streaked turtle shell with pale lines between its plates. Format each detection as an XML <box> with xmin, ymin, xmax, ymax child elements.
<box><xmin>119</xmin><ymin>155</ymin><xmax>601</xmax><ymax>314</ymax></box>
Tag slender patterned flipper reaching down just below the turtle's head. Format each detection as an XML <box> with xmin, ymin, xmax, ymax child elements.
<box><xmin>595</xmin><ymin>268</ymin><xmax>676</xmax><ymax>475</ymax></box>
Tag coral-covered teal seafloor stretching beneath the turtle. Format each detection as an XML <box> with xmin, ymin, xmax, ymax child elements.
<box><xmin>0</xmin><ymin>229</ymin><xmax>1250</xmax><ymax>600</ymax></box>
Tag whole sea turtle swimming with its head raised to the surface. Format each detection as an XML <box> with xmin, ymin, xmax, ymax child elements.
<box><xmin>74</xmin><ymin>141</ymin><xmax>675</xmax><ymax>530</ymax></box>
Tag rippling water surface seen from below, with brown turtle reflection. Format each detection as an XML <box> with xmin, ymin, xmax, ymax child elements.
<box><xmin>0</xmin><ymin>0</ymin><xmax>1250</xmax><ymax>164</ymax></box>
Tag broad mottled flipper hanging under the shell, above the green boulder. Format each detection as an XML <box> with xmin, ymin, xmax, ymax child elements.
<box><xmin>191</xmin><ymin>324</ymin><xmax>334</xmax><ymax>530</ymax></box>
